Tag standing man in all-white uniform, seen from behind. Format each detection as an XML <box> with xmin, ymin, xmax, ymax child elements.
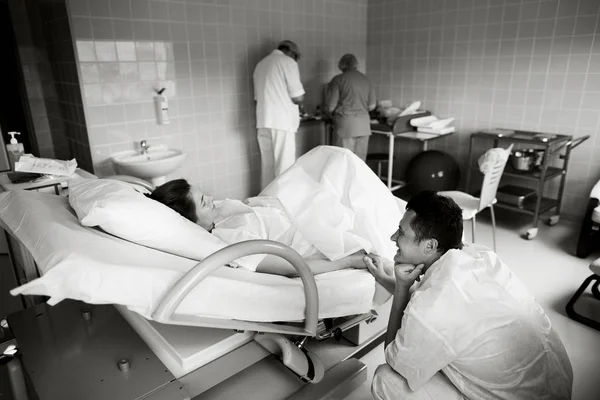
<box><xmin>253</xmin><ymin>40</ymin><xmax>305</xmax><ymax>188</ymax></box>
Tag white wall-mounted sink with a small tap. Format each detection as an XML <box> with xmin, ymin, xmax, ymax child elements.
<box><xmin>112</xmin><ymin>147</ymin><xmax>186</xmax><ymax>186</ymax></box>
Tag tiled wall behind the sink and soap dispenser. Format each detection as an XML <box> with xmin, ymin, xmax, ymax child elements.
<box><xmin>69</xmin><ymin>0</ymin><xmax>367</xmax><ymax>198</ymax></box>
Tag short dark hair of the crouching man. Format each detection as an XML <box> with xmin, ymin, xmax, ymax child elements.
<box><xmin>406</xmin><ymin>190</ymin><xmax>463</xmax><ymax>254</ymax></box>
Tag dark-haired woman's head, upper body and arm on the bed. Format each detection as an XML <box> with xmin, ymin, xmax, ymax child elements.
<box><xmin>147</xmin><ymin>179</ymin><xmax>366</xmax><ymax>276</ymax></box>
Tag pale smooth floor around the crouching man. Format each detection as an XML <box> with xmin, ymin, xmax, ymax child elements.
<box><xmin>347</xmin><ymin>211</ymin><xmax>600</xmax><ymax>400</ymax></box>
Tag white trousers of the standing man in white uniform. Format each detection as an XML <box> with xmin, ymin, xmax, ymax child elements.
<box><xmin>258</xmin><ymin>128</ymin><xmax>296</xmax><ymax>189</ymax></box>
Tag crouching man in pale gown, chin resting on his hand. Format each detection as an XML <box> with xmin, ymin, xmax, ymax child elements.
<box><xmin>365</xmin><ymin>192</ymin><xmax>573</xmax><ymax>400</ymax></box>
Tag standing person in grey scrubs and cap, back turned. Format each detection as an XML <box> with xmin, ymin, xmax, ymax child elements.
<box><xmin>326</xmin><ymin>54</ymin><xmax>376</xmax><ymax>161</ymax></box>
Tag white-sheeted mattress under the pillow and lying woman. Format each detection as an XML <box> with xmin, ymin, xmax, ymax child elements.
<box><xmin>0</xmin><ymin>191</ymin><xmax>389</xmax><ymax>322</ymax></box>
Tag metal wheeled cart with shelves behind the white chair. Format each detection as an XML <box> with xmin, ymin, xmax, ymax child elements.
<box><xmin>466</xmin><ymin>129</ymin><xmax>589</xmax><ymax>240</ymax></box>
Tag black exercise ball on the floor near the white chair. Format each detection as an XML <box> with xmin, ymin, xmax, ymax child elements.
<box><xmin>406</xmin><ymin>150</ymin><xmax>460</xmax><ymax>192</ymax></box>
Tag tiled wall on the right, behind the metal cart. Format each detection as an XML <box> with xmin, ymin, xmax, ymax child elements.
<box><xmin>368</xmin><ymin>0</ymin><xmax>600</xmax><ymax>219</ymax></box>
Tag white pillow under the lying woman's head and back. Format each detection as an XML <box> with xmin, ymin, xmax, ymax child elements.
<box><xmin>69</xmin><ymin>179</ymin><xmax>255</xmax><ymax>268</ymax></box>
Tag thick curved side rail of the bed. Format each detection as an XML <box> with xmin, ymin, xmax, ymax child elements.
<box><xmin>152</xmin><ymin>240</ymin><xmax>319</xmax><ymax>333</ymax></box>
